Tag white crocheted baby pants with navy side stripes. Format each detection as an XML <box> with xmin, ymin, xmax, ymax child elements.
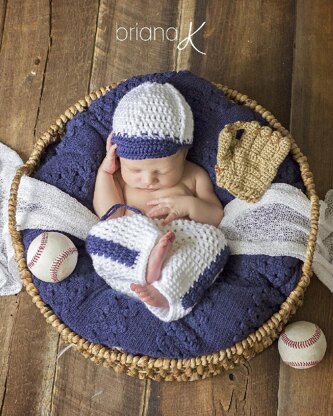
<box><xmin>86</xmin><ymin>205</ymin><xmax>229</xmax><ymax>322</ymax></box>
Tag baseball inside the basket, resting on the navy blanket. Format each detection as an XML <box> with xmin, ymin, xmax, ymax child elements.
<box><xmin>27</xmin><ymin>231</ymin><xmax>78</xmax><ymax>283</ymax></box>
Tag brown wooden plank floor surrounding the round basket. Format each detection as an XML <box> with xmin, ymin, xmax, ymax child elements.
<box><xmin>0</xmin><ymin>0</ymin><xmax>333</xmax><ymax>416</ymax></box>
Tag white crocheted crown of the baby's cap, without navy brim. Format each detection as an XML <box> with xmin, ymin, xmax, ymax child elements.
<box><xmin>112</xmin><ymin>82</ymin><xmax>193</xmax><ymax>145</ymax></box>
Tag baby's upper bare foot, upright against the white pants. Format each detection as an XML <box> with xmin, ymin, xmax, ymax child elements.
<box><xmin>146</xmin><ymin>231</ymin><xmax>176</xmax><ymax>283</ymax></box>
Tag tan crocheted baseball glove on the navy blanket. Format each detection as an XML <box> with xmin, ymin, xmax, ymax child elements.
<box><xmin>215</xmin><ymin>121</ymin><xmax>290</xmax><ymax>202</ymax></box>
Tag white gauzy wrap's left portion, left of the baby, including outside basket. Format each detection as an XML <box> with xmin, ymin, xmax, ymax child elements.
<box><xmin>0</xmin><ymin>143</ymin><xmax>98</xmax><ymax>296</ymax></box>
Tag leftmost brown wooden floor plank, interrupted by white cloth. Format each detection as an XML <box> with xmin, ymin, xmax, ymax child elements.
<box><xmin>0</xmin><ymin>0</ymin><xmax>54</xmax><ymax>415</ymax></box>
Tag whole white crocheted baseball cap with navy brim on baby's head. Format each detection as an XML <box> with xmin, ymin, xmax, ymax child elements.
<box><xmin>112</xmin><ymin>82</ymin><xmax>193</xmax><ymax>159</ymax></box>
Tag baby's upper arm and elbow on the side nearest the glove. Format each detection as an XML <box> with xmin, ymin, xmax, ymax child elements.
<box><xmin>189</xmin><ymin>167</ymin><xmax>223</xmax><ymax>227</ymax></box>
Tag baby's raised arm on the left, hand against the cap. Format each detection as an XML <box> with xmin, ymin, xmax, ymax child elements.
<box><xmin>93</xmin><ymin>134</ymin><xmax>125</xmax><ymax>218</ymax></box>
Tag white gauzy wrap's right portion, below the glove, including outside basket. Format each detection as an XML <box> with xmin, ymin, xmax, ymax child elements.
<box><xmin>221</xmin><ymin>183</ymin><xmax>333</xmax><ymax>292</ymax></box>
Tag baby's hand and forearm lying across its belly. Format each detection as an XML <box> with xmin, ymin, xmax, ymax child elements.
<box><xmin>147</xmin><ymin>195</ymin><xmax>194</xmax><ymax>225</ymax></box>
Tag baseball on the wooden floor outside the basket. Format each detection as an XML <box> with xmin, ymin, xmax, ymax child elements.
<box><xmin>278</xmin><ymin>321</ymin><xmax>327</xmax><ymax>369</ymax></box>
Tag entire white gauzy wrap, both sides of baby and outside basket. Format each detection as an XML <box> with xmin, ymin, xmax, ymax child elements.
<box><xmin>0</xmin><ymin>143</ymin><xmax>333</xmax><ymax>295</ymax></box>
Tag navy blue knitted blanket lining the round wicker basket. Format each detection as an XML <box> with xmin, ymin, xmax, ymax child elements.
<box><xmin>23</xmin><ymin>71</ymin><xmax>304</xmax><ymax>358</ymax></box>
